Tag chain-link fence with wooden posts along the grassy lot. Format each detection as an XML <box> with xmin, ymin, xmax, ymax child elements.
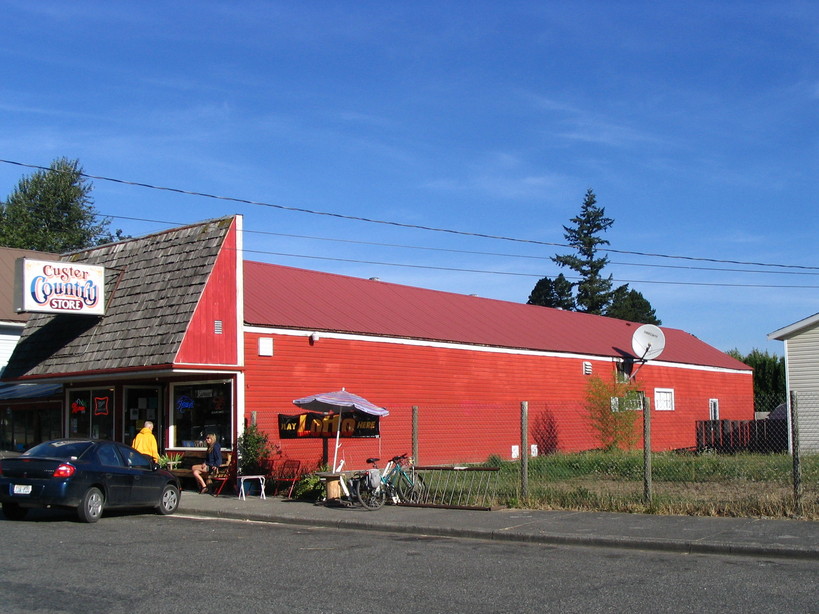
<box><xmin>370</xmin><ymin>393</ymin><xmax>819</xmax><ymax>519</ymax></box>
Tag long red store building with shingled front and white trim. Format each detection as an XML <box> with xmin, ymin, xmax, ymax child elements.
<box><xmin>4</xmin><ymin>217</ymin><xmax>753</xmax><ymax>465</ymax></box>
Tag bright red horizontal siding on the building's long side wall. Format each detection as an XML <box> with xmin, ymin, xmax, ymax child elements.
<box><xmin>245</xmin><ymin>332</ymin><xmax>753</xmax><ymax>465</ymax></box>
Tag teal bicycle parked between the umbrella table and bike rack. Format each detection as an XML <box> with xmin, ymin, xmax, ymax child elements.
<box><xmin>355</xmin><ymin>454</ymin><xmax>426</xmax><ymax>510</ymax></box>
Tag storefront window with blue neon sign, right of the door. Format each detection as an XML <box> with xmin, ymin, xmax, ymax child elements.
<box><xmin>171</xmin><ymin>382</ymin><xmax>233</xmax><ymax>448</ymax></box>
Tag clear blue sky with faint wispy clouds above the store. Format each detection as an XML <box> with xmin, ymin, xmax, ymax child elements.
<box><xmin>0</xmin><ymin>0</ymin><xmax>819</xmax><ymax>354</ymax></box>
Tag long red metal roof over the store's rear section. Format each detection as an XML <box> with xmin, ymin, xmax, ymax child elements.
<box><xmin>244</xmin><ymin>261</ymin><xmax>750</xmax><ymax>371</ymax></box>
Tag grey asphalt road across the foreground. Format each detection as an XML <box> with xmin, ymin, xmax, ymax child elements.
<box><xmin>0</xmin><ymin>512</ymin><xmax>819</xmax><ymax>614</ymax></box>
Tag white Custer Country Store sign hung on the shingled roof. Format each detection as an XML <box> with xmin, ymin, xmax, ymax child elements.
<box><xmin>14</xmin><ymin>258</ymin><xmax>105</xmax><ymax>316</ymax></box>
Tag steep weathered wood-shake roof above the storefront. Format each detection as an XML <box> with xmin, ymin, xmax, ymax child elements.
<box><xmin>3</xmin><ymin>217</ymin><xmax>234</xmax><ymax>379</ymax></box>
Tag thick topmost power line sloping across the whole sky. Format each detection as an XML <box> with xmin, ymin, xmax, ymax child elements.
<box><xmin>0</xmin><ymin>159</ymin><xmax>819</xmax><ymax>270</ymax></box>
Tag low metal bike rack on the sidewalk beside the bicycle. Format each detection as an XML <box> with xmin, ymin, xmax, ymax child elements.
<box><xmin>408</xmin><ymin>466</ymin><xmax>500</xmax><ymax>511</ymax></box>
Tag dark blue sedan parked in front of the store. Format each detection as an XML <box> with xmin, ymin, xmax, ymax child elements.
<box><xmin>0</xmin><ymin>439</ymin><xmax>180</xmax><ymax>522</ymax></box>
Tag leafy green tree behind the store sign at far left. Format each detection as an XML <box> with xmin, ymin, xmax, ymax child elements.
<box><xmin>0</xmin><ymin>158</ymin><xmax>122</xmax><ymax>253</ymax></box>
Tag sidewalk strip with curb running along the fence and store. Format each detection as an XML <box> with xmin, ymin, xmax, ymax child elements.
<box><xmin>177</xmin><ymin>491</ymin><xmax>819</xmax><ymax>560</ymax></box>
